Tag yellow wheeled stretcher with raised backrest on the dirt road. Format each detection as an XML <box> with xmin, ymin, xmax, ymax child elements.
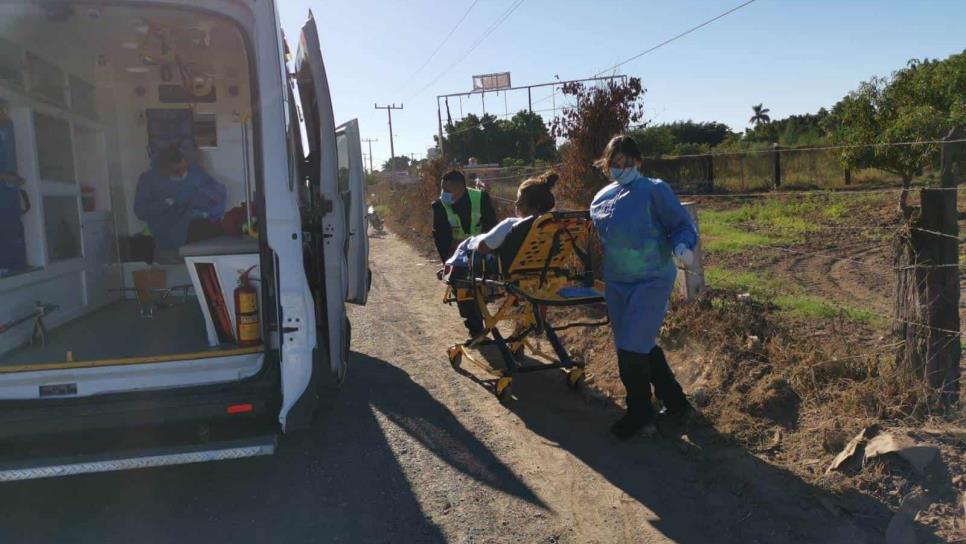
<box><xmin>440</xmin><ymin>211</ymin><xmax>608</xmax><ymax>403</ymax></box>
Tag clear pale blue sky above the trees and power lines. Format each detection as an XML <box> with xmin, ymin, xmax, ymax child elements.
<box><xmin>279</xmin><ymin>0</ymin><xmax>966</xmax><ymax>169</ymax></box>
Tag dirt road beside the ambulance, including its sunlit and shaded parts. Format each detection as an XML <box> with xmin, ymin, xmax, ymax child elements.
<box><xmin>0</xmin><ymin>235</ymin><xmax>887</xmax><ymax>544</ymax></box>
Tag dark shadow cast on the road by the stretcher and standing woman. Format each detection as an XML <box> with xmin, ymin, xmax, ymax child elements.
<box><xmin>461</xmin><ymin>349</ymin><xmax>935</xmax><ymax>543</ymax></box>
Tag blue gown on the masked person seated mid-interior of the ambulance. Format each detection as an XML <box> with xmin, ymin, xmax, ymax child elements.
<box><xmin>134</xmin><ymin>166</ymin><xmax>226</xmax><ymax>249</ymax></box>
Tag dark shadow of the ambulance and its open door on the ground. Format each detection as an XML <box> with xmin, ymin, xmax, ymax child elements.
<box><xmin>0</xmin><ymin>354</ymin><xmax>539</xmax><ymax>543</ymax></box>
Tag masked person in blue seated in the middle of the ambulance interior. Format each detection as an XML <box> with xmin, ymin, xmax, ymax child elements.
<box><xmin>134</xmin><ymin>147</ymin><xmax>226</xmax><ymax>250</ymax></box>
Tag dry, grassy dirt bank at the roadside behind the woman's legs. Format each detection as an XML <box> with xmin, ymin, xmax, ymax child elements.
<box><xmin>563</xmin><ymin>291</ymin><xmax>966</xmax><ymax>539</ymax></box>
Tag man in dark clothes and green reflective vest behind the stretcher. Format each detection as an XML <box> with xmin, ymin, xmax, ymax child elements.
<box><xmin>433</xmin><ymin>170</ymin><xmax>496</xmax><ymax>338</ymax></box>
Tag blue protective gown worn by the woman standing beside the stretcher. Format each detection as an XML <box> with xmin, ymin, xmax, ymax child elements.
<box><xmin>590</xmin><ymin>176</ymin><xmax>698</xmax><ymax>353</ymax></box>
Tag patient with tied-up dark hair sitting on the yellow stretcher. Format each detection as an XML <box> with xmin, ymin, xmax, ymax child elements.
<box><xmin>446</xmin><ymin>172</ymin><xmax>560</xmax><ymax>277</ymax></box>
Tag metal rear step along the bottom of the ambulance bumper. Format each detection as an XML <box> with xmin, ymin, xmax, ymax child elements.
<box><xmin>0</xmin><ymin>435</ymin><xmax>278</xmax><ymax>482</ymax></box>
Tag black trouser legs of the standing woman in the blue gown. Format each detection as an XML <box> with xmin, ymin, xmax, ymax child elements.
<box><xmin>617</xmin><ymin>346</ymin><xmax>688</xmax><ymax>420</ymax></box>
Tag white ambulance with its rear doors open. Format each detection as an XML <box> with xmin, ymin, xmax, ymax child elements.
<box><xmin>0</xmin><ymin>0</ymin><xmax>370</xmax><ymax>481</ymax></box>
